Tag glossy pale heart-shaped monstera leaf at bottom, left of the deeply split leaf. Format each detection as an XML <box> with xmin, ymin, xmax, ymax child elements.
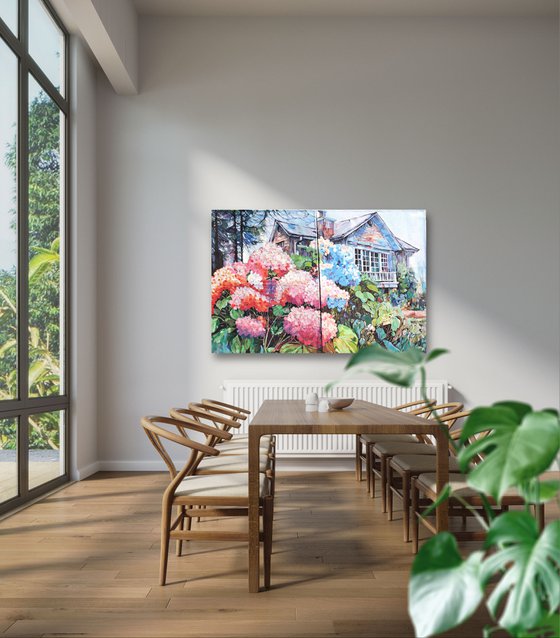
<box><xmin>408</xmin><ymin>532</ymin><xmax>484</xmax><ymax>638</ymax></box>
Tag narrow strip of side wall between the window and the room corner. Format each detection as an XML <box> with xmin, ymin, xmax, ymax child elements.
<box><xmin>70</xmin><ymin>36</ymin><xmax>98</xmax><ymax>478</ymax></box>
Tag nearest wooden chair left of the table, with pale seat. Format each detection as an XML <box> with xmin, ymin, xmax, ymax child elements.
<box><xmin>141</xmin><ymin>416</ymin><xmax>274</xmax><ymax>588</ymax></box>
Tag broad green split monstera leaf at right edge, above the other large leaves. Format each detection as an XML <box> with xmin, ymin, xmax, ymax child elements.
<box><xmin>459</xmin><ymin>402</ymin><xmax>560</xmax><ymax>501</ymax></box>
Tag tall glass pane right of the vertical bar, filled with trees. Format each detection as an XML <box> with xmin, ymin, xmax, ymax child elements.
<box><xmin>29</xmin><ymin>76</ymin><xmax>64</xmax><ymax>397</ymax></box>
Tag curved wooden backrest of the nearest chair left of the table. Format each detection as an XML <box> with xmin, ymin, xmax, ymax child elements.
<box><xmin>140</xmin><ymin>416</ymin><xmax>219</xmax><ymax>479</ymax></box>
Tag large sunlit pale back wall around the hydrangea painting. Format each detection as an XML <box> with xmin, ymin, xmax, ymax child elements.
<box><xmin>97</xmin><ymin>13</ymin><xmax>559</xmax><ymax>468</ymax></box>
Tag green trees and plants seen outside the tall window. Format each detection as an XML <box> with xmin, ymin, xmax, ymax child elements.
<box><xmin>0</xmin><ymin>92</ymin><xmax>61</xmax><ymax>449</ymax></box>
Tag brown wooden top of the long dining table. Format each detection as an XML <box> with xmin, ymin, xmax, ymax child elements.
<box><xmin>249</xmin><ymin>400</ymin><xmax>439</xmax><ymax>434</ymax></box>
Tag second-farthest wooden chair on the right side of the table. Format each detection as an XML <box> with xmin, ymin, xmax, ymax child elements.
<box><xmin>369</xmin><ymin>402</ymin><xmax>463</xmax><ymax>513</ymax></box>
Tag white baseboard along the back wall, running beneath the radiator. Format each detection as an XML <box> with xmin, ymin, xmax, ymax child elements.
<box><xmin>95</xmin><ymin>456</ymin><xmax>354</xmax><ymax>480</ymax></box>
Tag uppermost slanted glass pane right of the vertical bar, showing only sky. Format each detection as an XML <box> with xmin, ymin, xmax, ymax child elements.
<box><xmin>29</xmin><ymin>0</ymin><xmax>65</xmax><ymax>95</ymax></box>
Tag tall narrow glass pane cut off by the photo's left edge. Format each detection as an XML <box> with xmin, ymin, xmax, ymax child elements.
<box><xmin>0</xmin><ymin>40</ymin><xmax>18</xmax><ymax>400</ymax></box>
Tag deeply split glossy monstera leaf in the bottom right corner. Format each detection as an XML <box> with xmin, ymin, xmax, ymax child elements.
<box><xmin>482</xmin><ymin>512</ymin><xmax>560</xmax><ymax>635</ymax></box>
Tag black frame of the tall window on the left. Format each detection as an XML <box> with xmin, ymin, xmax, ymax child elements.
<box><xmin>0</xmin><ymin>0</ymin><xmax>72</xmax><ymax>515</ymax></box>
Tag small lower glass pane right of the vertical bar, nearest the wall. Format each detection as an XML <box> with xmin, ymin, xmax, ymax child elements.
<box><xmin>29</xmin><ymin>410</ymin><xmax>65</xmax><ymax>490</ymax></box>
